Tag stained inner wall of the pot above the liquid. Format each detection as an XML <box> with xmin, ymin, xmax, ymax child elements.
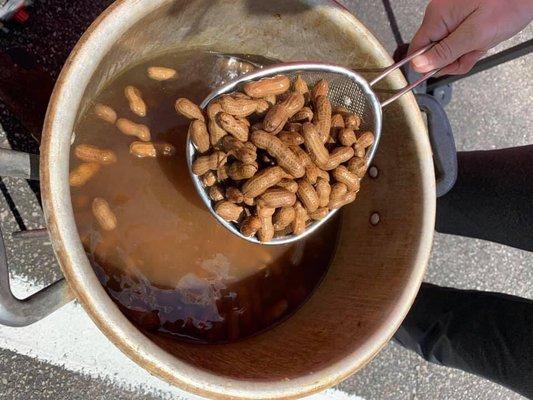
<box><xmin>77</xmin><ymin>0</ymin><xmax>433</xmax><ymax>381</ymax></box>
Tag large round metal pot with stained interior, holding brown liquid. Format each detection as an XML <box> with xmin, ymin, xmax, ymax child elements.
<box><xmin>0</xmin><ymin>0</ymin><xmax>436</xmax><ymax>399</ymax></box>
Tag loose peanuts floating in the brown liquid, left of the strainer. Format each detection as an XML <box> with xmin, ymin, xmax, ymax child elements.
<box><xmin>69</xmin><ymin>67</ymin><xmax>177</xmax><ymax>231</ymax></box>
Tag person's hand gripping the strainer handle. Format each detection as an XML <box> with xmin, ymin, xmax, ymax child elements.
<box><xmin>409</xmin><ymin>0</ymin><xmax>533</xmax><ymax>75</ymax></box>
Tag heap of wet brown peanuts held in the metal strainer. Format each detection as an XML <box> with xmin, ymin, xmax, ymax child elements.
<box><xmin>184</xmin><ymin>75</ymin><xmax>374</xmax><ymax>242</ymax></box>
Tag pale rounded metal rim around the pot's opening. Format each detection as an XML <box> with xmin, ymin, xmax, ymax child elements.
<box><xmin>40</xmin><ymin>0</ymin><xmax>436</xmax><ymax>399</ymax></box>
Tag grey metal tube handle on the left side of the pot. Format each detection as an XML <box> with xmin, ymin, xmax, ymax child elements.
<box><xmin>0</xmin><ymin>148</ymin><xmax>74</xmax><ymax>327</ymax></box>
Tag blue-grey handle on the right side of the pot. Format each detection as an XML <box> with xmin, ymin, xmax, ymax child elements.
<box><xmin>415</xmin><ymin>93</ymin><xmax>457</xmax><ymax>197</ymax></box>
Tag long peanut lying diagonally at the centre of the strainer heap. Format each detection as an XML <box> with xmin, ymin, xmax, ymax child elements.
<box><xmin>251</xmin><ymin>131</ymin><xmax>305</xmax><ymax>178</ymax></box>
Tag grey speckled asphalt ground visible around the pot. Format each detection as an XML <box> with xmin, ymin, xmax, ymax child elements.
<box><xmin>0</xmin><ymin>0</ymin><xmax>533</xmax><ymax>400</ymax></box>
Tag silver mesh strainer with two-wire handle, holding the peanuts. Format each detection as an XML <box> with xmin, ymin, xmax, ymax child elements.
<box><xmin>187</xmin><ymin>44</ymin><xmax>439</xmax><ymax>245</ymax></box>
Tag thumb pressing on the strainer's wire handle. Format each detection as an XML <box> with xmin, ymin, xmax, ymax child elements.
<box><xmin>412</xmin><ymin>22</ymin><xmax>478</xmax><ymax>73</ymax></box>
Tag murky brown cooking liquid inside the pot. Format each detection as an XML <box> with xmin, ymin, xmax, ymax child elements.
<box><xmin>70</xmin><ymin>52</ymin><xmax>339</xmax><ymax>342</ymax></box>
